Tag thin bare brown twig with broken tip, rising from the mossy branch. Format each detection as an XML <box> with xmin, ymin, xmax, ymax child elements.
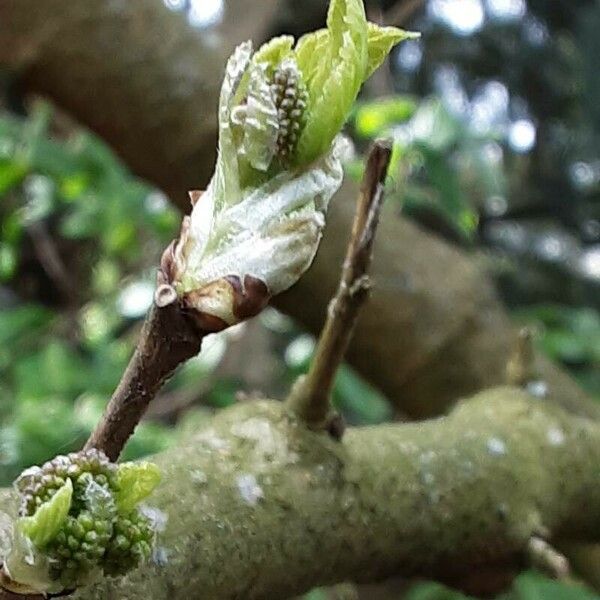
<box><xmin>287</xmin><ymin>140</ymin><xmax>392</xmax><ymax>429</ymax></box>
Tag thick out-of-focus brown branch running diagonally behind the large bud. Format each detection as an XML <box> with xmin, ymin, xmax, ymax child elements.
<box><xmin>0</xmin><ymin>0</ymin><xmax>600</xmax><ymax>417</ymax></box>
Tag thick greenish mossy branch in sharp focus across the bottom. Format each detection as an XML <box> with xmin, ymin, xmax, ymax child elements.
<box><xmin>0</xmin><ymin>387</ymin><xmax>600</xmax><ymax>600</ymax></box>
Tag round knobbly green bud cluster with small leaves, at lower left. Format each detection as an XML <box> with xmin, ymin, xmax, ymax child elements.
<box><xmin>3</xmin><ymin>449</ymin><xmax>159</xmax><ymax>593</ymax></box>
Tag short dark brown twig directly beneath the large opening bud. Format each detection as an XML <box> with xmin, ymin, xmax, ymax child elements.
<box><xmin>85</xmin><ymin>302</ymin><xmax>204</xmax><ymax>461</ymax></box>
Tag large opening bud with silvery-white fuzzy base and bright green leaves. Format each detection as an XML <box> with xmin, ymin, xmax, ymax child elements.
<box><xmin>155</xmin><ymin>0</ymin><xmax>412</xmax><ymax>331</ymax></box>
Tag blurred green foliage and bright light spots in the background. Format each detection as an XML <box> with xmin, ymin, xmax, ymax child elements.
<box><xmin>0</xmin><ymin>0</ymin><xmax>600</xmax><ymax>600</ymax></box>
